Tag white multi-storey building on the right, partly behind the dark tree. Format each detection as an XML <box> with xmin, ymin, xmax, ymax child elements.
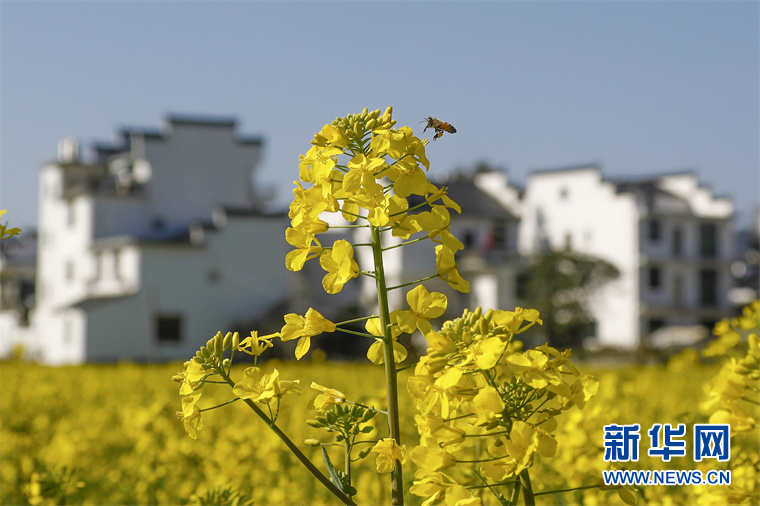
<box><xmin>519</xmin><ymin>166</ymin><xmax>733</xmax><ymax>349</ymax></box>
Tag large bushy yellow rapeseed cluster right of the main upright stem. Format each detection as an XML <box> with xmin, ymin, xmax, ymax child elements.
<box><xmin>408</xmin><ymin>308</ymin><xmax>598</xmax><ymax>505</ymax></box>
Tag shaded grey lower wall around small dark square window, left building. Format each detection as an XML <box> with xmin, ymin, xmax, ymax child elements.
<box><xmin>81</xmin><ymin>217</ymin><xmax>289</xmax><ymax>361</ymax></box>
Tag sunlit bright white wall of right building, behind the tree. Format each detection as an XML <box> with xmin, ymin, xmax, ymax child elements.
<box><xmin>518</xmin><ymin>167</ymin><xmax>639</xmax><ymax>347</ymax></box>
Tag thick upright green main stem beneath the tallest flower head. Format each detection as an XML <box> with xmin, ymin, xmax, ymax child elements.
<box><xmin>371</xmin><ymin>227</ymin><xmax>404</xmax><ymax>505</ymax></box>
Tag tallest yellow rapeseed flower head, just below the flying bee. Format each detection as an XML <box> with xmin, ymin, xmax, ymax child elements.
<box><xmin>285</xmin><ymin>107</ymin><xmax>469</xmax><ymax>293</ymax></box>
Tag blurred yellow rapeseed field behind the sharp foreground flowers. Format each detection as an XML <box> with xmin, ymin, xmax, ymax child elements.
<box><xmin>0</xmin><ymin>354</ymin><xmax>760</xmax><ymax>505</ymax></box>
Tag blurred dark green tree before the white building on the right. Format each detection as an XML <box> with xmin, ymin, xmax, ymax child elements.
<box><xmin>520</xmin><ymin>250</ymin><xmax>620</xmax><ymax>348</ymax></box>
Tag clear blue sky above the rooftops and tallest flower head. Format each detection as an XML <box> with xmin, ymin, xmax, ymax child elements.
<box><xmin>0</xmin><ymin>1</ymin><xmax>760</xmax><ymax>226</ymax></box>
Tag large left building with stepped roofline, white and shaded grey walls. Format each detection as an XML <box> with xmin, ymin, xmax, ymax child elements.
<box><xmin>25</xmin><ymin>116</ymin><xmax>289</xmax><ymax>364</ymax></box>
